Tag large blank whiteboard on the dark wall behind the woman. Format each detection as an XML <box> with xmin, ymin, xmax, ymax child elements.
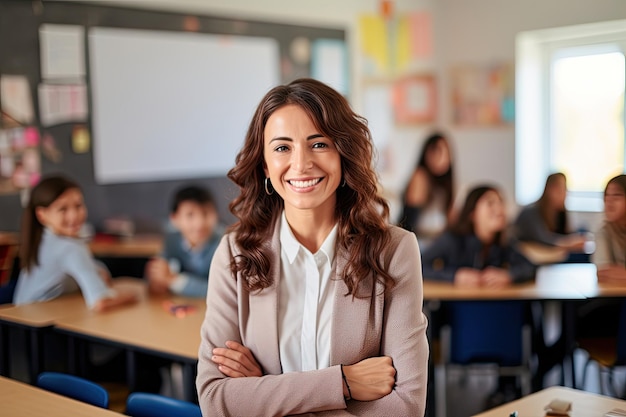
<box><xmin>88</xmin><ymin>27</ymin><xmax>280</xmax><ymax>184</ymax></box>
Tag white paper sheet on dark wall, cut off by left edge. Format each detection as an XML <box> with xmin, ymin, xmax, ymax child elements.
<box><xmin>0</xmin><ymin>75</ymin><xmax>34</xmax><ymax>124</ymax></box>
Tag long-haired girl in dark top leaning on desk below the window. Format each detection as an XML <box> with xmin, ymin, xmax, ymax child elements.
<box><xmin>514</xmin><ymin>172</ymin><xmax>585</xmax><ymax>253</ymax></box>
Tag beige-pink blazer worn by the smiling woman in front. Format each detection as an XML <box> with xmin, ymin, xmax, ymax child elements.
<box><xmin>196</xmin><ymin>222</ymin><xmax>428</xmax><ymax>417</ymax></box>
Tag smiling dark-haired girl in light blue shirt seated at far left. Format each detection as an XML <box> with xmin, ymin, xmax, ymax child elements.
<box><xmin>13</xmin><ymin>175</ymin><xmax>138</xmax><ymax>311</ymax></box>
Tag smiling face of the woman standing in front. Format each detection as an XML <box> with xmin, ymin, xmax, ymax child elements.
<box><xmin>263</xmin><ymin>105</ymin><xmax>342</xmax><ymax>215</ymax></box>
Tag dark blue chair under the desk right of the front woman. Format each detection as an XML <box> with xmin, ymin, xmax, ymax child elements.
<box><xmin>438</xmin><ymin>301</ymin><xmax>532</xmax><ymax>415</ymax></box>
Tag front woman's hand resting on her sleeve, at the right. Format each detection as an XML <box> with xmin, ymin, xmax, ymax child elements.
<box><xmin>343</xmin><ymin>356</ymin><xmax>396</xmax><ymax>401</ymax></box>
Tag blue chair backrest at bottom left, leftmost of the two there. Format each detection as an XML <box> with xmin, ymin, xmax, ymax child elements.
<box><xmin>37</xmin><ymin>372</ymin><xmax>109</xmax><ymax>408</ymax></box>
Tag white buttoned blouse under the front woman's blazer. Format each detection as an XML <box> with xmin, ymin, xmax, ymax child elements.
<box><xmin>278</xmin><ymin>212</ymin><xmax>337</xmax><ymax>372</ymax></box>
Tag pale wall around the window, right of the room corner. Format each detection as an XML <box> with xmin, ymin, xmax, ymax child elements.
<box><xmin>433</xmin><ymin>0</ymin><xmax>626</xmax><ymax>229</ymax></box>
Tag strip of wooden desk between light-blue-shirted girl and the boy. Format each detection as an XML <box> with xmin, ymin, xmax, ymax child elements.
<box><xmin>89</xmin><ymin>235</ymin><xmax>163</xmax><ymax>258</ymax></box>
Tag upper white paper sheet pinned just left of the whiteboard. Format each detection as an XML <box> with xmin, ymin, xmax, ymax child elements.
<box><xmin>39</xmin><ymin>24</ymin><xmax>85</xmax><ymax>80</ymax></box>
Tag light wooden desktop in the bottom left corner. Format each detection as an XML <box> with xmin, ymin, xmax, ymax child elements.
<box><xmin>0</xmin><ymin>377</ymin><xmax>121</xmax><ymax>417</ymax></box>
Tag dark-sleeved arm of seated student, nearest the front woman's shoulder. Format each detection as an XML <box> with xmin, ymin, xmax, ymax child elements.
<box><xmin>422</xmin><ymin>232</ymin><xmax>458</xmax><ymax>283</ymax></box>
